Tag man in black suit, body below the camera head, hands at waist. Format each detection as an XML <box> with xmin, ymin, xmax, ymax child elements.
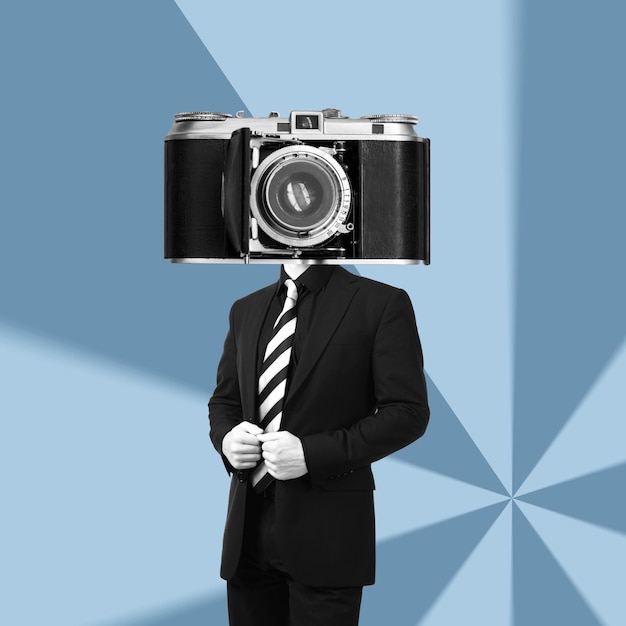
<box><xmin>209</xmin><ymin>265</ymin><xmax>429</xmax><ymax>626</ymax></box>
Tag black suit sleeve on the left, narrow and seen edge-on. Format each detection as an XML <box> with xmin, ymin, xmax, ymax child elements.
<box><xmin>209</xmin><ymin>305</ymin><xmax>243</xmax><ymax>473</ymax></box>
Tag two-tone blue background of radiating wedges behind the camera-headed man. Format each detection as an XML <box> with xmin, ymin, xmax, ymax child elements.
<box><xmin>0</xmin><ymin>0</ymin><xmax>626</xmax><ymax>626</ymax></box>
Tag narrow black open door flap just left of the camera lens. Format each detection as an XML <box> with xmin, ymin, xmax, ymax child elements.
<box><xmin>222</xmin><ymin>128</ymin><xmax>250</xmax><ymax>256</ymax></box>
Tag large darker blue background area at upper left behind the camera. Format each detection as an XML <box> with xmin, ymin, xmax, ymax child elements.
<box><xmin>0</xmin><ymin>0</ymin><xmax>276</xmax><ymax>390</ymax></box>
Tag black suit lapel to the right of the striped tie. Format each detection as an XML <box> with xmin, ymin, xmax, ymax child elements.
<box><xmin>287</xmin><ymin>268</ymin><xmax>358</xmax><ymax>401</ymax></box>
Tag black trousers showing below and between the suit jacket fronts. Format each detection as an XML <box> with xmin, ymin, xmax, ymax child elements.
<box><xmin>227</xmin><ymin>485</ymin><xmax>363</xmax><ymax>626</ymax></box>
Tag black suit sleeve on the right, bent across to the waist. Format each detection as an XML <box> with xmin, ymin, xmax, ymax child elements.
<box><xmin>302</xmin><ymin>290</ymin><xmax>430</xmax><ymax>485</ymax></box>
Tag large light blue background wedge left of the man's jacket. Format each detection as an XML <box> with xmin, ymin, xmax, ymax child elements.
<box><xmin>0</xmin><ymin>323</ymin><xmax>229</xmax><ymax>626</ymax></box>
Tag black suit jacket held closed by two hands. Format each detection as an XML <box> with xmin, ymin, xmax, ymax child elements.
<box><xmin>209</xmin><ymin>268</ymin><xmax>429</xmax><ymax>586</ymax></box>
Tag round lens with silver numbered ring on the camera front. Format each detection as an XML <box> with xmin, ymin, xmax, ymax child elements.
<box><xmin>250</xmin><ymin>145</ymin><xmax>352</xmax><ymax>248</ymax></box>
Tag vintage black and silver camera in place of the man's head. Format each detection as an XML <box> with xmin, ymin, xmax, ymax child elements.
<box><xmin>165</xmin><ymin>109</ymin><xmax>430</xmax><ymax>264</ymax></box>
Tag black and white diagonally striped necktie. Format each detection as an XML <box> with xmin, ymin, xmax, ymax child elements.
<box><xmin>252</xmin><ymin>278</ymin><xmax>298</xmax><ymax>493</ymax></box>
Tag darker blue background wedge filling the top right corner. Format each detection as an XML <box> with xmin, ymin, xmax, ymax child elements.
<box><xmin>514</xmin><ymin>0</ymin><xmax>626</xmax><ymax>491</ymax></box>
